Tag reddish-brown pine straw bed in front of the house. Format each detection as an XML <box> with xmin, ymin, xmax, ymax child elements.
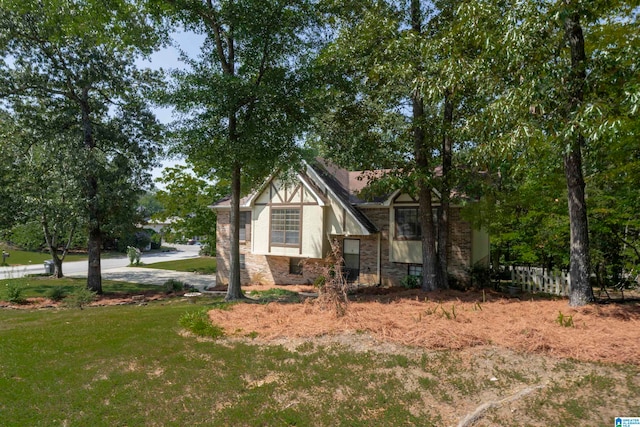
<box><xmin>209</xmin><ymin>290</ymin><xmax>640</xmax><ymax>364</ymax></box>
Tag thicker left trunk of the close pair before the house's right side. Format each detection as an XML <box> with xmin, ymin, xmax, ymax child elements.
<box><xmin>410</xmin><ymin>0</ymin><xmax>441</xmax><ymax>291</ymax></box>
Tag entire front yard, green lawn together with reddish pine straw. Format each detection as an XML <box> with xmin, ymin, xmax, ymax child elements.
<box><xmin>0</xmin><ymin>280</ymin><xmax>640</xmax><ymax>427</ymax></box>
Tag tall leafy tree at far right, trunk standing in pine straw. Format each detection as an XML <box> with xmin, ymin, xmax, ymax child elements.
<box><xmin>460</xmin><ymin>0</ymin><xmax>638</xmax><ymax>305</ymax></box>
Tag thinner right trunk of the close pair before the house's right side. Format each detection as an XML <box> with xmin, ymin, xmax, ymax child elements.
<box><xmin>438</xmin><ymin>90</ymin><xmax>453</xmax><ymax>289</ymax></box>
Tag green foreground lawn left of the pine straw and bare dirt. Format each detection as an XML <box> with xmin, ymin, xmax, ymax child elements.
<box><xmin>0</xmin><ymin>300</ymin><xmax>439</xmax><ymax>426</ymax></box>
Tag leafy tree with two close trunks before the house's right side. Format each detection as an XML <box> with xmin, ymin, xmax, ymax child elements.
<box><xmin>312</xmin><ymin>0</ymin><xmax>481</xmax><ymax>290</ymax></box>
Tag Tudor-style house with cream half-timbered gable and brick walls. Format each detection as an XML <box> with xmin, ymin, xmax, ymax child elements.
<box><xmin>212</xmin><ymin>162</ymin><xmax>489</xmax><ymax>285</ymax></box>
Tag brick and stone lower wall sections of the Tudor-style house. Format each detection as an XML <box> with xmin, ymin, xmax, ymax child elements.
<box><xmin>216</xmin><ymin>207</ymin><xmax>472</xmax><ymax>285</ymax></box>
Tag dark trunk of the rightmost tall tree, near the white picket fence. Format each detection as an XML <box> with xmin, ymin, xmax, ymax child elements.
<box><xmin>564</xmin><ymin>7</ymin><xmax>594</xmax><ymax>306</ymax></box>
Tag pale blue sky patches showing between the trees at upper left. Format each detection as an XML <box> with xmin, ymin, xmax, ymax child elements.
<box><xmin>138</xmin><ymin>32</ymin><xmax>204</xmax><ymax>188</ymax></box>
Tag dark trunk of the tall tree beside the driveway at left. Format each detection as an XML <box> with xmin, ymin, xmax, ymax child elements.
<box><xmin>80</xmin><ymin>93</ymin><xmax>102</xmax><ymax>294</ymax></box>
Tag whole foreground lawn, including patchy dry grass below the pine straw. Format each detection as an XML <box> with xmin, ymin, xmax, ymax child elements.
<box><xmin>0</xmin><ymin>298</ymin><xmax>640</xmax><ymax>426</ymax></box>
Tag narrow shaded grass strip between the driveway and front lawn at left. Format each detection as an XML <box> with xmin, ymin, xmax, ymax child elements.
<box><xmin>0</xmin><ymin>276</ymin><xmax>164</xmax><ymax>301</ymax></box>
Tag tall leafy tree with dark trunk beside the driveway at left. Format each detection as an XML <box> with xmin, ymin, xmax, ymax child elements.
<box><xmin>0</xmin><ymin>0</ymin><xmax>165</xmax><ymax>292</ymax></box>
